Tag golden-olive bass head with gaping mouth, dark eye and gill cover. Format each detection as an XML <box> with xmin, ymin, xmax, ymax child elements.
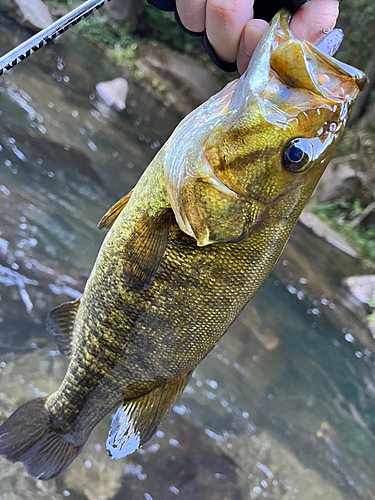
<box><xmin>165</xmin><ymin>10</ymin><xmax>368</xmax><ymax>246</ymax></box>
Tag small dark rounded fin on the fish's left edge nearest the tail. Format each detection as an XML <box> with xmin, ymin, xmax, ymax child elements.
<box><xmin>46</xmin><ymin>299</ymin><xmax>81</xmax><ymax>358</ymax></box>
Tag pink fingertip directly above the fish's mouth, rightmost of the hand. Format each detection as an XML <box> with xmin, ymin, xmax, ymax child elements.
<box><xmin>290</xmin><ymin>0</ymin><xmax>339</xmax><ymax>43</ymax></box>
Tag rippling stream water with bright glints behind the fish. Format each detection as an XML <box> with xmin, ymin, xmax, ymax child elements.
<box><xmin>0</xmin><ymin>13</ymin><xmax>375</xmax><ymax>500</ymax></box>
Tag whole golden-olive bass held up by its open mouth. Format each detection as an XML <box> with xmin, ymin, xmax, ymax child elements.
<box><xmin>0</xmin><ymin>10</ymin><xmax>368</xmax><ymax>480</ymax></box>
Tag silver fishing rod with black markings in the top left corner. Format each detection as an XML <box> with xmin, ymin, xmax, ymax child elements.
<box><xmin>0</xmin><ymin>0</ymin><xmax>110</xmax><ymax>75</ymax></box>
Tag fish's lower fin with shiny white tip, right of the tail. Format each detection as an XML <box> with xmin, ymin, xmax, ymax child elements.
<box><xmin>106</xmin><ymin>371</ymin><xmax>192</xmax><ymax>458</ymax></box>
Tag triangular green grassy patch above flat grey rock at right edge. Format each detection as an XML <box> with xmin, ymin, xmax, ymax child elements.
<box><xmin>313</xmin><ymin>199</ymin><xmax>375</xmax><ymax>262</ymax></box>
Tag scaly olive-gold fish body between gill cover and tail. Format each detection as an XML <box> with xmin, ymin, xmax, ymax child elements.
<box><xmin>47</xmin><ymin>177</ymin><xmax>298</xmax><ymax>433</ymax></box>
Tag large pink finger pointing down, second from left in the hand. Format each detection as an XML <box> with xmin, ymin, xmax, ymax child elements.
<box><xmin>206</xmin><ymin>0</ymin><xmax>254</xmax><ymax>63</ymax></box>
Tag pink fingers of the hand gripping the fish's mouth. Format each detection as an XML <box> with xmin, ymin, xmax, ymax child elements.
<box><xmin>176</xmin><ymin>0</ymin><xmax>339</xmax><ymax>74</ymax></box>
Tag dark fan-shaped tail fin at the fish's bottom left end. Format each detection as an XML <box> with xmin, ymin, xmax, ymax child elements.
<box><xmin>0</xmin><ymin>398</ymin><xmax>83</xmax><ymax>481</ymax></box>
